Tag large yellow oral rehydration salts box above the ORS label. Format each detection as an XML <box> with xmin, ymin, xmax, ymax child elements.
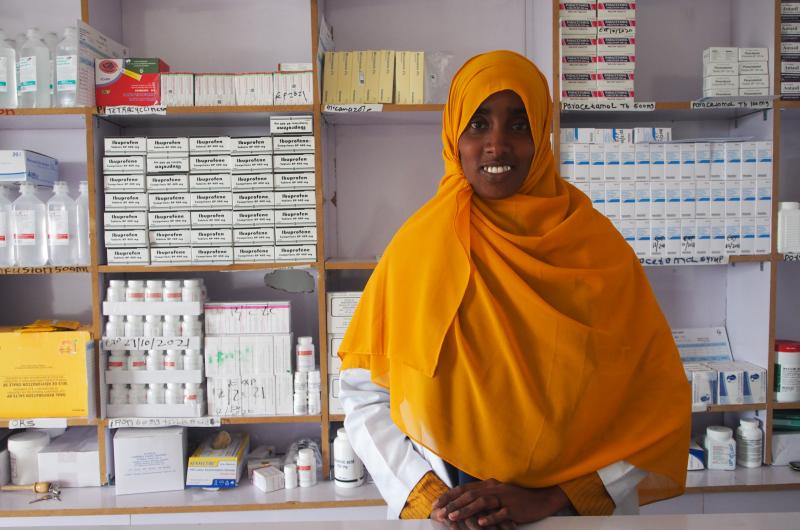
<box><xmin>0</xmin><ymin>331</ymin><xmax>95</xmax><ymax>419</ymax></box>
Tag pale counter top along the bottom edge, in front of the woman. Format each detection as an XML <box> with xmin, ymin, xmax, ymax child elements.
<box><xmin>1</xmin><ymin>513</ymin><xmax>800</xmax><ymax>530</ymax></box>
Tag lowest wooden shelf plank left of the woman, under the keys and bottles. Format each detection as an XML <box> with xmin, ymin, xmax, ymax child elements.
<box><xmin>0</xmin><ymin>480</ymin><xmax>385</xmax><ymax>517</ymax></box>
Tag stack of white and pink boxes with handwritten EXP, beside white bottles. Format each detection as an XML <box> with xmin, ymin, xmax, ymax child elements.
<box><xmin>204</xmin><ymin>302</ymin><xmax>294</xmax><ymax>416</ymax></box>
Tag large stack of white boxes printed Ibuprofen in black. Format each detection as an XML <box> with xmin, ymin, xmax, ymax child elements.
<box><xmin>103</xmin><ymin>116</ymin><xmax>317</xmax><ymax>265</ymax></box>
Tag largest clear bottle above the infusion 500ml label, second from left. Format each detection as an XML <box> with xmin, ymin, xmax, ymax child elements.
<box><xmin>11</xmin><ymin>182</ymin><xmax>47</xmax><ymax>267</ymax></box>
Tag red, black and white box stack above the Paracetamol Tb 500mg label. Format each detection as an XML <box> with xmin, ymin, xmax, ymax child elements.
<box><xmin>559</xmin><ymin>0</ymin><xmax>636</xmax><ymax>103</ymax></box>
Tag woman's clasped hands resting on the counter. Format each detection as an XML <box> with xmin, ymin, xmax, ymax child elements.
<box><xmin>431</xmin><ymin>479</ymin><xmax>570</xmax><ymax>530</ymax></box>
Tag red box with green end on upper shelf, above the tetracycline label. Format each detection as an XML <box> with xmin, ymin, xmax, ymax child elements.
<box><xmin>94</xmin><ymin>58</ymin><xmax>169</xmax><ymax>107</ymax></box>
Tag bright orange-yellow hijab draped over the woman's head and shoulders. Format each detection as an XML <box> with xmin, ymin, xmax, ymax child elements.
<box><xmin>339</xmin><ymin>51</ymin><xmax>691</xmax><ymax>503</ymax></box>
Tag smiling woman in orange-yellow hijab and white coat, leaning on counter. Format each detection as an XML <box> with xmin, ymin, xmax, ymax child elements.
<box><xmin>339</xmin><ymin>51</ymin><xmax>691</xmax><ymax>528</ymax></box>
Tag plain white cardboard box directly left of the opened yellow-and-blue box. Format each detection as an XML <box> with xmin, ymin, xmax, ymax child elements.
<box><xmin>114</xmin><ymin>427</ymin><xmax>187</xmax><ymax>495</ymax></box>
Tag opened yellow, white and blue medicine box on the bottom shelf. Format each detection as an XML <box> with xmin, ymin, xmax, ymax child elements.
<box><xmin>186</xmin><ymin>433</ymin><xmax>250</xmax><ymax>488</ymax></box>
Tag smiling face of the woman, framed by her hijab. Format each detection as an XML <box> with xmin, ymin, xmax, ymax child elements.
<box><xmin>458</xmin><ymin>90</ymin><xmax>534</xmax><ymax>199</ymax></box>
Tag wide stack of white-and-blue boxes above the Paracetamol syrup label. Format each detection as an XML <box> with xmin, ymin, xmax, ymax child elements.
<box><xmin>561</xmin><ymin>128</ymin><xmax>772</xmax><ymax>259</ymax></box>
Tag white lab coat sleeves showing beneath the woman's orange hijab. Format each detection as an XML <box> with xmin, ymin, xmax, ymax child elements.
<box><xmin>339</xmin><ymin>368</ymin><xmax>645</xmax><ymax>519</ymax></box>
